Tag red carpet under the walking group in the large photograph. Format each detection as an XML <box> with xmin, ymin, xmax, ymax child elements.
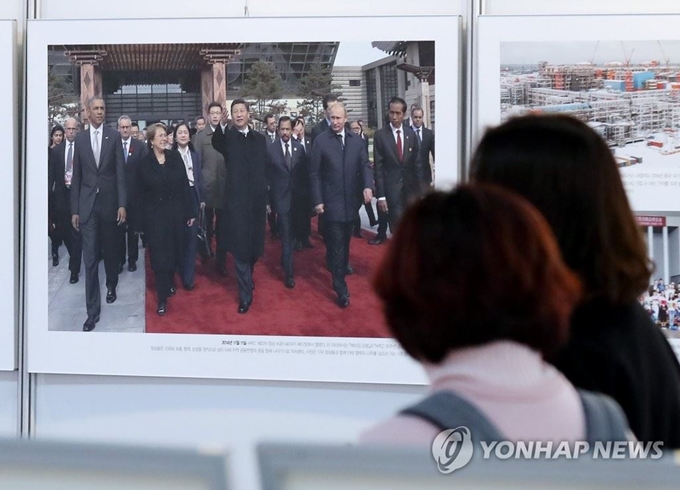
<box><xmin>146</xmin><ymin>218</ymin><xmax>390</xmax><ymax>338</ymax></box>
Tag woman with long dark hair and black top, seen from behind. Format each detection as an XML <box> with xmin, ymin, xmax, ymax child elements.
<box><xmin>471</xmin><ymin>115</ymin><xmax>680</xmax><ymax>449</ymax></box>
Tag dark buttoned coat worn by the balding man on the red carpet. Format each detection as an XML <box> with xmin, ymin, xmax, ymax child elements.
<box><xmin>309</xmin><ymin>128</ymin><xmax>373</xmax><ymax>222</ymax></box>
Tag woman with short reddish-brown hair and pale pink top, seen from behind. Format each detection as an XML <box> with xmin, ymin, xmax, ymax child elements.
<box><xmin>361</xmin><ymin>186</ymin><xmax>628</xmax><ymax>447</ymax></box>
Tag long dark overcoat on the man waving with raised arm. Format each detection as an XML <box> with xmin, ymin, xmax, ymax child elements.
<box><xmin>212</xmin><ymin>127</ymin><xmax>269</xmax><ymax>263</ymax></box>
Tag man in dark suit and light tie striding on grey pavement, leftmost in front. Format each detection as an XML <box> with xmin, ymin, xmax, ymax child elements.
<box><xmin>71</xmin><ymin>97</ymin><xmax>126</xmax><ymax>332</ymax></box>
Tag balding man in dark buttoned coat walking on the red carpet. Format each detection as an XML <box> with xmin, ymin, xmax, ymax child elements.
<box><xmin>309</xmin><ymin>102</ymin><xmax>373</xmax><ymax>308</ymax></box>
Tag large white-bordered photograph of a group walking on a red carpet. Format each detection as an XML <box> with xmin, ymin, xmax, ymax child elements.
<box><xmin>26</xmin><ymin>17</ymin><xmax>459</xmax><ymax>384</ymax></box>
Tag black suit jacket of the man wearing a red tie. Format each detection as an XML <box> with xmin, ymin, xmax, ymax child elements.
<box><xmin>373</xmin><ymin>124</ymin><xmax>424</xmax><ymax>205</ymax></box>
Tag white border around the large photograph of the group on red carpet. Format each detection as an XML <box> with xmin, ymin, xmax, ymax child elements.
<box><xmin>26</xmin><ymin>16</ymin><xmax>460</xmax><ymax>384</ymax></box>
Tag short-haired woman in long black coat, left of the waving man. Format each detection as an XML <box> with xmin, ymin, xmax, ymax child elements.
<box><xmin>138</xmin><ymin>124</ymin><xmax>196</xmax><ymax>316</ymax></box>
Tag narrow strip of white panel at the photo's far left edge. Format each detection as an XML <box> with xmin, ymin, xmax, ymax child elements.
<box><xmin>0</xmin><ymin>20</ymin><xmax>19</xmax><ymax>371</ymax></box>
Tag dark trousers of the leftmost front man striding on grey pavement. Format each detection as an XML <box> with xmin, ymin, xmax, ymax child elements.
<box><xmin>80</xmin><ymin>198</ymin><xmax>120</xmax><ymax>316</ymax></box>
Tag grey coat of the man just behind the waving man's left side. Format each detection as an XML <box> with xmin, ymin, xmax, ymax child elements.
<box><xmin>194</xmin><ymin>124</ymin><xmax>227</xmax><ymax>209</ymax></box>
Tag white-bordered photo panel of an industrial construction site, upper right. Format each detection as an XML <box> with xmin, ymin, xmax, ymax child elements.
<box><xmin>473</xmin><ymin>15</ymin><xmax>680</xmax><ymax>213</ymax></box>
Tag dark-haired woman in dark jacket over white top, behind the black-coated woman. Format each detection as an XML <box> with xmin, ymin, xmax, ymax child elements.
<box><xmin>172</xmin><ymin>123</ymin><xmax>205</xmax><ymax>291</ymax></box>
